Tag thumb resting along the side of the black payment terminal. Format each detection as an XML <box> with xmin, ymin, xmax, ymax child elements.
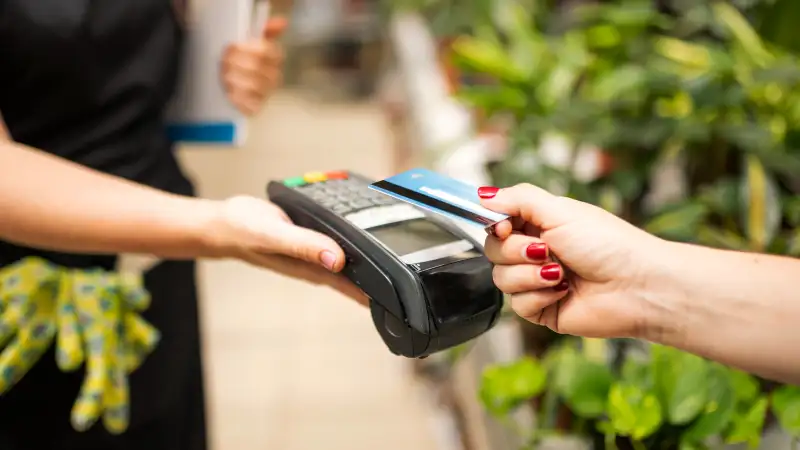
<box><xmin>270</xmin><ymin>222</ymin><xmax>345</xmax><ymax>272</ymax></box>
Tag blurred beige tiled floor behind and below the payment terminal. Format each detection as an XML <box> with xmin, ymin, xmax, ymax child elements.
<box><xmin>176</xmin><ymin>93</ymin><xmax>435</xmax><ymax>450</ymax></box>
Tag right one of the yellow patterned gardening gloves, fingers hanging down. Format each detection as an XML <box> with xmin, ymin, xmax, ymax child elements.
<box><xmin>57</xmin><ymin>270</ymin><xmax>159</xmax><ymax>433</ymax></box>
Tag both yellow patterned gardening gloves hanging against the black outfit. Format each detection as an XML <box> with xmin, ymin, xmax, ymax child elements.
<box><xmin>0</xmin><ymin>258</ymin><xmax>159</xmax><ymax>433</ymax></box>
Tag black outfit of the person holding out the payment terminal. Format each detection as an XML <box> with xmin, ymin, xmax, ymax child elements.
<box><xmin>0</xmin><ymin>0</ymin><xmax>206</xmax><ymax>450</ymax></box>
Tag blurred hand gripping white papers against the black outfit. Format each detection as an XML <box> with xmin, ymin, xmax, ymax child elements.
<box><xmin>221</xmin><ymin>17</ymin><xmax>287</xmax><ymax>116</ymax></box>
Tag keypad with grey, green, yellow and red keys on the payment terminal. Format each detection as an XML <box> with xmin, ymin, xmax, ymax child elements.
<box><xmin>283</xmin><ymin>172</ymin><xmax>399</xmax><ymax>216</ymax></box>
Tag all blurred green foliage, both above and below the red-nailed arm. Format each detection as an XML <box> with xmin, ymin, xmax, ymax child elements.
<box><xmin>438</xmin><ymin>0</ymin><xmax>800</xmax><ymax>450</ymax></box>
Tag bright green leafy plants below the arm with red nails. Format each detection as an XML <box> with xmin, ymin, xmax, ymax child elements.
<box><xmin>480</xmin><ymin>344</ymin><xmax>772</xmax><ymax>449</ymax></box>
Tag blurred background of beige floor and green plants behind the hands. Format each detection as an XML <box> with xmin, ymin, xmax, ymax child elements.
<box><xmin>181</xmin><ymin>0</ymin><xmax>800</xmax><ymax>450</ymax></box>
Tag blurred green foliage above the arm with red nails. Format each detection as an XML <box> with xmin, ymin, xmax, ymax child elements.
<box><xmin>453</xmin><ymin>0</ymin><xmax>800</xmax><ymax>246</ymax></box>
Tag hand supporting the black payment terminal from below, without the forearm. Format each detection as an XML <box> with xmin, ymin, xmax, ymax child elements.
<box><xmin>205</xmin><ymin>196</ymin><xmax>367</xmax><ymax>304</ymax></box>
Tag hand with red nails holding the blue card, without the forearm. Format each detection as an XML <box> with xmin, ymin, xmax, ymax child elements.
<box><xmin>478</xmin><ymin>184</ymin><xmax>669</xmax><ymax>337</ymax></box>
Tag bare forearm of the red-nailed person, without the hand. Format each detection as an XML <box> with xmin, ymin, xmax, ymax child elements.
<box><xmin>649</xmin><ymin>244</ymin><xmax>800</xmax><ymax>383</ymax></box>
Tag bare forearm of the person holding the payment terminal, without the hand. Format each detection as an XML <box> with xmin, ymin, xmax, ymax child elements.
<box><xmin>0</xmin><ymin>139</ymin><xmax>220</xmax><ymax>258</ymax></box>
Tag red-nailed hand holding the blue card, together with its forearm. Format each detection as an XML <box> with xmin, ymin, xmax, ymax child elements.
<box><xmin>478</xmin><ymin>184</ymin><xmax>800</xmax><ymax>384</ymax></box>
